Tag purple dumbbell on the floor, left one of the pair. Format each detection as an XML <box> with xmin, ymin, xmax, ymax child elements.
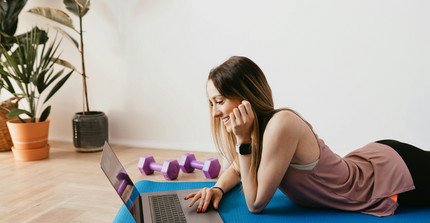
<box><xmin>137</xmin><ymin>156</ymin><xmax>179</xmax><ymax>180</ymax></box>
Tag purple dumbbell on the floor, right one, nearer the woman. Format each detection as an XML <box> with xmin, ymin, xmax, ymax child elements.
<box><xmin>179</xmin><ymin>153</ymin><xmax>221</xmax><ymax>179</ymax></box>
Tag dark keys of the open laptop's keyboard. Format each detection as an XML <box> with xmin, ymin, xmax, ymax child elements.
<box><xmin>148</xmin><ymin>194</ymin><xmax>187</xmax><ymax>223</ymax></box>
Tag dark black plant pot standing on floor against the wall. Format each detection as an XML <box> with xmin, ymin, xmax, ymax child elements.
<box><xmin>73</xmin><ymin>111</ymin><xmax>109</xmax><ymax>152</ymax></box>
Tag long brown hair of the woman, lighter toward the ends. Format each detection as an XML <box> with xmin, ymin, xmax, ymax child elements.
<box><xmin>208</xmin><ymin>56</ymin><xmax>277</xmax><ymax>178</ymax></box>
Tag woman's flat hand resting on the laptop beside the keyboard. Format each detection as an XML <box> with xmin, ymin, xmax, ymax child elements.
<box><xmin>185</xmin><ymin>187</ymin><xmax>223</xmax><ymax>212</ymax></box>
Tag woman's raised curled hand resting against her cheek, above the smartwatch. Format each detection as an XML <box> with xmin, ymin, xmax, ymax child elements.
<box><xmin>230</xmin><ymin>100</ymin><xmax>254</xmax><ymax>144</ymax></box>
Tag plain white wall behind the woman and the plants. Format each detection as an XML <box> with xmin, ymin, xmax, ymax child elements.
<box><xmin>2</xmin><ymin>0</ymin><xmax>430</xmax><ymax>155</ymax></box>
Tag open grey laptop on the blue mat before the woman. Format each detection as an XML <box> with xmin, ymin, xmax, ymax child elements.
<box><xmin>100</xmin><ymin>142</ymin><xmax>223</xmax><ymax>223</ymax></box>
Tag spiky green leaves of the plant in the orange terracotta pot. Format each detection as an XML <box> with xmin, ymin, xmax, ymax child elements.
<box><xmin>0</xmin><ymin>26</ymin><xmax>74</xmax><ymax>122</ymax></box>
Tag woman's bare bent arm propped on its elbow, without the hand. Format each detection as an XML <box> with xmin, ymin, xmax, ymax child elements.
<box><xmin>236</xmin><ymin>106</ymin><xmax>303</xmax><ymax>213</ymax></box>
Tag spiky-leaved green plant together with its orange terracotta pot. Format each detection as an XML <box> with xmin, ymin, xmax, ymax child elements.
<box><xmin>0</xmin><ymin>29</ymin><xmax>74</xmax><ymax>161</ymax></box>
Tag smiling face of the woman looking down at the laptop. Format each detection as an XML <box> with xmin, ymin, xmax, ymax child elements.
<box><xmin>206</xmin><ymin>80</ymin><xmax>241</xmax><ymax>133</ymax></box>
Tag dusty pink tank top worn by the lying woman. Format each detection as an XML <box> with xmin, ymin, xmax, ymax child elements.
<box><xmin>279</xmin><ymin>137</ymin><xmax>415</xmax><ymax>216</ymax></box>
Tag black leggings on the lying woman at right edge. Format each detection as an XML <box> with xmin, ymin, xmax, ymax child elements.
<box><xmin>377</xmin><ymin>140</ymin><xmax>430</xmax><ymax>206</ymax></box>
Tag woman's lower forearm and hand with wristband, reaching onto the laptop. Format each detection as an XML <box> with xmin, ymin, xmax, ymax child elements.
<box><xmin>185</xmin><ymin>165</ymin><xmax>240</xmax><ymax>212</ymax></box>
